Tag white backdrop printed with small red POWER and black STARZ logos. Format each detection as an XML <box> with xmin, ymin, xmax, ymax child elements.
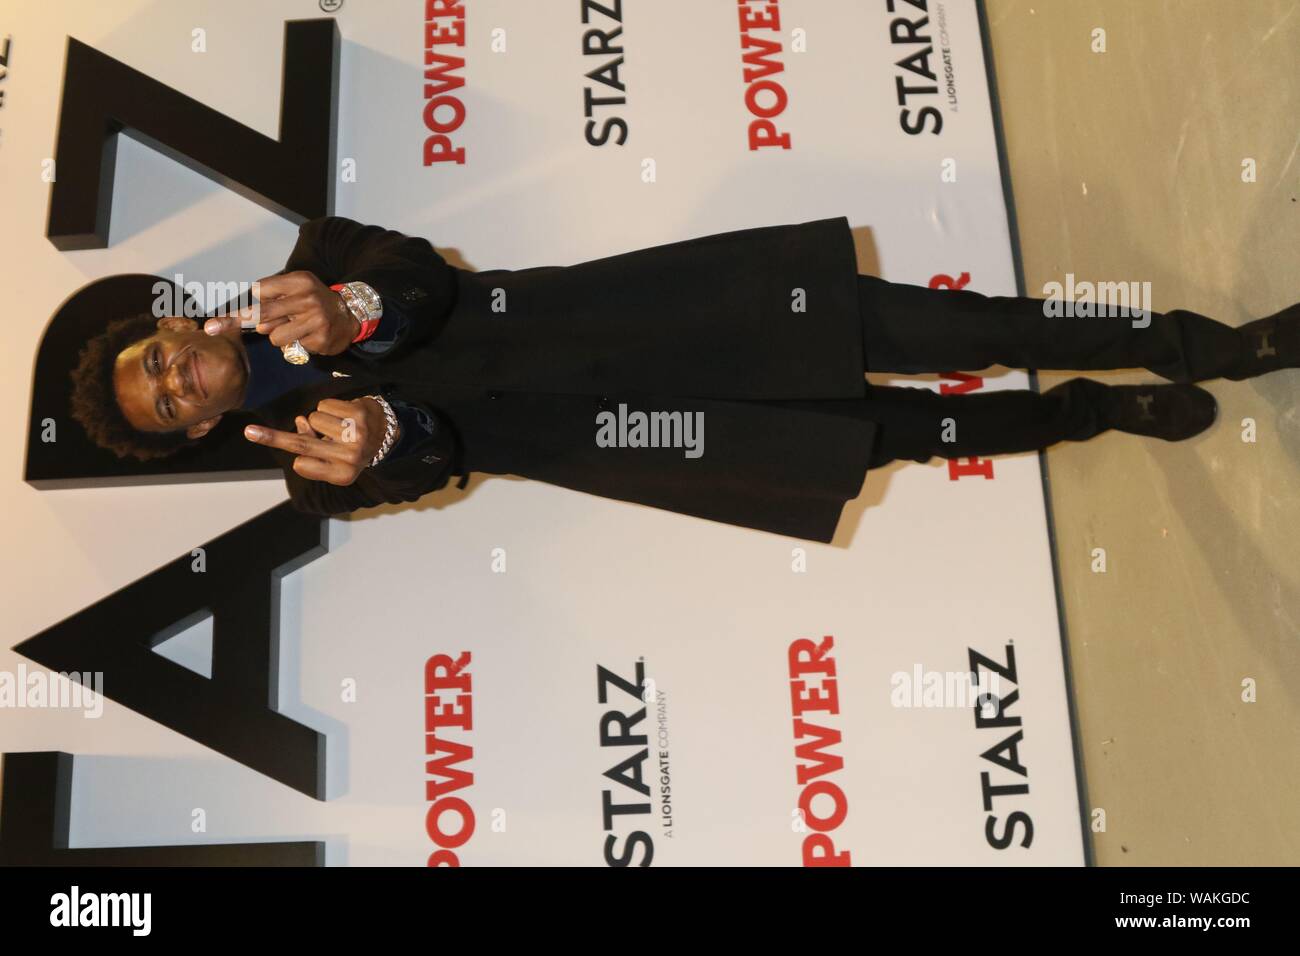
<box><xmin>0</xmin><ymin>0</ymin><xmax>1083</xmax><ymax>865</ymax></box>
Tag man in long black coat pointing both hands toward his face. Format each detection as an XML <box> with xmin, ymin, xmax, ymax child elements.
<box><xmin>73</xmin><ymin>217</ymin><xmax>1300</xmax><ymax>541</ymax></box>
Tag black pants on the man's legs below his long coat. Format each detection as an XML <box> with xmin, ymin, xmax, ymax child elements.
<box><xmin>842</xmin><ymin>276</ymin><xmax>1242</xmax><ymax>467</ymax></box>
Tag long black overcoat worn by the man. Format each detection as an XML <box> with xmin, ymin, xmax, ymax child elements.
<box><xmin>257</xmin><ymin>216</ymin><xmax>875</xmax><ymax>541</ymax></box>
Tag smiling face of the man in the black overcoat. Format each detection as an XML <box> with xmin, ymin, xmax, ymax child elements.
<box><xmin>113</xmin><ymin>316</ymin><xmax>248</xmax><ymax>438</ymax></box>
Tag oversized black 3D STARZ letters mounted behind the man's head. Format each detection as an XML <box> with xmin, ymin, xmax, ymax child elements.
<box><xmin>0</xmin><ymin>20</ymin><xmax>339</xmax><ymax>865</ymax></box>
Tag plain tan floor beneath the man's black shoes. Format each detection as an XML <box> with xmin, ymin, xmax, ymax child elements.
<box><xmin>985</xmin><ymin>0</ymin><xmax>1300</xmax><ymax>866</ymax></box>
